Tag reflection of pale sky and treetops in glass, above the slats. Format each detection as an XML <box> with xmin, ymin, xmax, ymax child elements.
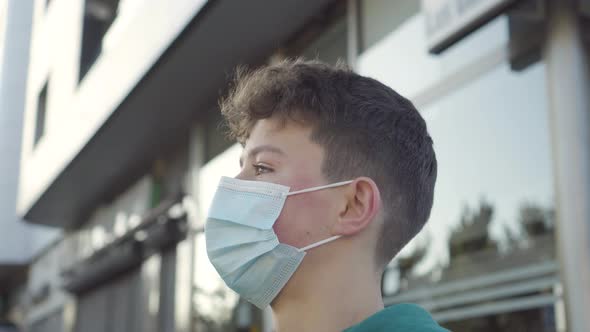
<box><xmin>418</xmin><ymin>64</ymin><xmax>553</xmax><ymax>273</ymax></box>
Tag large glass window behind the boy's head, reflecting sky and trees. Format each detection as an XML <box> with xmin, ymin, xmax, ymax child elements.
<box><xmin>358</xmin><ymin>9</ymin><xmax>561</xmax><ymax>331</ymax></box>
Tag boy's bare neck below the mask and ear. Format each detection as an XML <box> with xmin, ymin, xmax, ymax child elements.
<box><xmin>272</xmin><ymin>250</ymin><xmax>383</xmax><ymax>332</ymax></box>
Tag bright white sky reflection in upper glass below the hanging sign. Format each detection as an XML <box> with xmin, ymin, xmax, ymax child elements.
<box><xmin>358</xmin><ymin>14</ymin><xmax>508</xmax><ymax>98</ymax></box>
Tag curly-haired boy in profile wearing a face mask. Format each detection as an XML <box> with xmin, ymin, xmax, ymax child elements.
<box><xmin>205</xmin><ymin>60</ymin><xmax>446</xmax><ymax>332</ymax></box>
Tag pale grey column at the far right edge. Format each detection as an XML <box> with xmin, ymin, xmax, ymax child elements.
<box><xmin>544</xmin><ymin>0</ymin><xmax>590</xmax><ymax>332</ymax></box>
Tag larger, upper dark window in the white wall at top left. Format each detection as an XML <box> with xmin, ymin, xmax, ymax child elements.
<box><xmin>78</xmin><ymin>0</ymin><xmax>119</xmax><ymax>81</ymax></box>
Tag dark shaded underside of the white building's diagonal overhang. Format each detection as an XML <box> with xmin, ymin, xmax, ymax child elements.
<box><xmin>24</xmin><ymin>0</ymin><xmax>332</xmax><ymax>228</ymax></box>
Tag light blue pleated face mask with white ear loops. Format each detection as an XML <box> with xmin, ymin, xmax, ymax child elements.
<box><xmin>205</xmin><ymin>177</ymin><xmax>352</xmax><ymax>309</ymax></box>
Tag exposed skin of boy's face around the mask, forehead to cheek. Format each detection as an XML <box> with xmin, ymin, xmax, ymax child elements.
<box><xmin>236</xmin><ymin>118</ymin><xmax>345</xmax><ymax>248</ymax></box>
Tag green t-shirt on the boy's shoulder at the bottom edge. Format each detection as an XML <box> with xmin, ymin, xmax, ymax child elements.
<box><xmin>344</xmin><ymin>303</ymin><xmax>448</xmax><ymax>332</ymax></box>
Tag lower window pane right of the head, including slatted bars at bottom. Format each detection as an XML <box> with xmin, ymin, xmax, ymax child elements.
<box><xmin>383</xmin><ymin>64</ymin><xmax>559</xmax><ymax>331</ymax></box>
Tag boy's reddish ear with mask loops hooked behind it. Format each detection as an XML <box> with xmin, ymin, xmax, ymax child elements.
<box><xmin>332</xmin><ymin>177</ymin><xmax>381</xmax><ymax>235</ymax></box>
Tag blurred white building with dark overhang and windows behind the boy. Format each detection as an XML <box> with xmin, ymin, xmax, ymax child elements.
<box><xmin>16</xmin><ymin>0</ymin><xmax>590</xmax><ymax>332</ymax></box>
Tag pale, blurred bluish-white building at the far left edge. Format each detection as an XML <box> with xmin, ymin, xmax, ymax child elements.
<box><xmin>0</xmin><ymin>0</ymin><xmax>59</xmax><ymax>330</ymax></box>
